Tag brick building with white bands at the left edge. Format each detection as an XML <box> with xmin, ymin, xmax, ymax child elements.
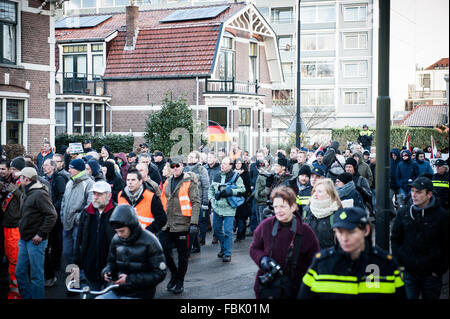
<box><xmin>0</xmin><ymin>0</ymin><xmax>56</xmax><ymax>154</ymax></box>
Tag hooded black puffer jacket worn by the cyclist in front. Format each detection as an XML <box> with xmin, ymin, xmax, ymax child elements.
<box><xmin>102</xmin><ymin>205</ymin><xmax>167</xmax><ymax>298</ymax></box>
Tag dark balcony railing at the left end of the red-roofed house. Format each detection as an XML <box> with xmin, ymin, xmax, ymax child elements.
<box><xmin>56</xmin><ymin>72</ymin><xmax>106</xmax><ymax>95</ymax></box>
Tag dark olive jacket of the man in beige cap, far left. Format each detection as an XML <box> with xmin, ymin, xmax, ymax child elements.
<box><xmin>19</xmin><ymin>181</ymin><xmax>58</xmax><ymax>241</ymax></box>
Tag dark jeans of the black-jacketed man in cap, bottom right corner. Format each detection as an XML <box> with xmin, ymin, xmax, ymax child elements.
<box><xmin>403</xmin><ymin>271</ymin><xmax>442</xmax><ymax>299</ymax></box>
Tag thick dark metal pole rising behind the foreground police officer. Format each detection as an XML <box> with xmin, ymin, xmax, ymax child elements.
<box><xmin>375</xmin><ymin>0</ymin><xmax>392</xmax><ymax>251</ymax></box>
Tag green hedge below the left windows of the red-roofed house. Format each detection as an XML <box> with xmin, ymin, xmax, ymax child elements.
<box><xmin>55</xmin><ymin>134</ymin><xmax>134</xmax><ymax>153</ymax></box>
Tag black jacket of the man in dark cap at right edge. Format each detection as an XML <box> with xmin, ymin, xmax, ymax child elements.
<box><xmin>391</xmin><ymin>196</ymin><xmax>449</xmax><ymax>275</ymax></box>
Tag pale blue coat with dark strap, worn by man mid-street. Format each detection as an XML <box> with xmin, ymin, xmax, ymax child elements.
<box><xmin>208</xmin><ymin>170</ymin><xmax>245</xmax><ymax>216</ymax></box>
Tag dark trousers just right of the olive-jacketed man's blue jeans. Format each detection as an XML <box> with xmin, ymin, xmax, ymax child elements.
<box><xmin>44</xmin><ymin>217</ymin><xmax>62</xmax><ymax>279</ymax></box>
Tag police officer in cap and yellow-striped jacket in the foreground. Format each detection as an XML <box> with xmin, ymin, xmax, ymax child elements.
<box><xmin>297</xmin><ymin>207</ymin><xmax>405</xmax><ymax>299</ymax></box>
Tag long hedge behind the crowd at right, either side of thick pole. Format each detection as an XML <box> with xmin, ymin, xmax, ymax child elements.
<box><xmin>332</xmin><ymin>126</ymin><xmax>449</xmax><ymax>153</ymax></box>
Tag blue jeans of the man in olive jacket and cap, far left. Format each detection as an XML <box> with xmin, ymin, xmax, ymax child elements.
<box><xmin>16</xmin><ymin>239</ymin><xmax>48</xmax><ymax>299</ymax></box>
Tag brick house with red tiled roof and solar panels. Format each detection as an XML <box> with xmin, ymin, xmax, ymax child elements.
<box><xmin>55</xmin><ymin>3</ymin><xmax>283</xmax><ymax>153</ymax></box>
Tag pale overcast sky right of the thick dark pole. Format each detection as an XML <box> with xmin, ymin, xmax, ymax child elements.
<box><xmin>388</xmin><ymin>0</ymin><xmax>449</xmax><ymax>112</ymax></box>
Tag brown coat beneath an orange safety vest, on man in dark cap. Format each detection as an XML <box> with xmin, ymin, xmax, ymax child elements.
<box><xmin>161</xmin><ymin>172</ymin><xmax>201</xmax><ymax>233</ymax></box>
